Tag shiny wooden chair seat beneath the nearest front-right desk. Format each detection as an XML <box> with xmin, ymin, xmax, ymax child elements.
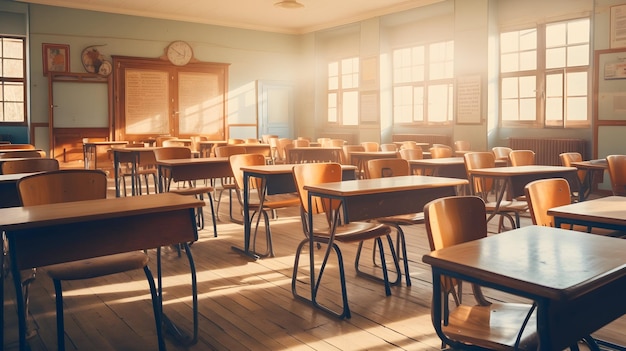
<box><xmin>442</xmin><ymin>303</ymin><xmax>538</xmax><ymax>350</ymax></box>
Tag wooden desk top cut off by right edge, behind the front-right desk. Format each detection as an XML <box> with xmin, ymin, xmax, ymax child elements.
<box><xmin>548</xmin><ymin>196</ymin><xmax>626</xmax><ymax>226</ymax></box>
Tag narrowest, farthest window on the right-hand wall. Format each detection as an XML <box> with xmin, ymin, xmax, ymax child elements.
<box><xmin>328</xmin><ymin>57</ymin><xmax>359</xmax><ymax>126</ymax></box>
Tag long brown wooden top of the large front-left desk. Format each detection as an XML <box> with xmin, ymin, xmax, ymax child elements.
<box><xmin>0</xmin><ymin>193</ymin><xmax>205</xmax><ymax>231</ymax></box>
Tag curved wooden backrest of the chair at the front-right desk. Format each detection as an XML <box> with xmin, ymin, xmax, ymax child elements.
<box><xmin>424</xmin><ymin>196</ymin><xmax>487</xmax><ymax>250</ymax></box>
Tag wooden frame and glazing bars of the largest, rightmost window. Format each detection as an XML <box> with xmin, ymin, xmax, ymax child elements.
<box><xmin>498</xmin><ymin>16</ymin><xmax>593</xmax><ymax>129</ymax></box>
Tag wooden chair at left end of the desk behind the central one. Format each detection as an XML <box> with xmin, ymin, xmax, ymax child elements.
<box><xmin>230</xmin><ymin>154</ymin><xmax>300</xmax><ymax>257</ymax></box>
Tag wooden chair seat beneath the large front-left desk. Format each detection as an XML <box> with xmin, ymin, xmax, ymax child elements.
<box><xmin>46</xmin><ymin>251</ymin><xmax>148</xmax><ymax>280</ymax></box>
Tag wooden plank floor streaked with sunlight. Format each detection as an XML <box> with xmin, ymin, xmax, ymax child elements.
<box><xmin>4</xmin><ymin>180</ymin><xmax>626</xmax><ymax>351</ymax></box>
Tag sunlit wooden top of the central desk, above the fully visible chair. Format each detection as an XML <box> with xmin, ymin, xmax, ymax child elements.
<box><xmin>304</xmin><ymin>176</ymin><xmax>468</xmax><ymax>197</ymax></box>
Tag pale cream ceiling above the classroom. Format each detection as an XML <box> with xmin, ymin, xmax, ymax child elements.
<box><xmin>18</xmin><ymin>0</ymin><xmax>443</xmax><ymax>34</ymax></box>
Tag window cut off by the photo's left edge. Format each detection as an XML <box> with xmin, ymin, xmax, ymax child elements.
<box><xmin>0</xmin><ymin>36</ymin><xmax>26</xmax><ymax>124</ymax></box>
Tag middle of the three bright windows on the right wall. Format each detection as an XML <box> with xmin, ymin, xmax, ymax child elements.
<box><xmin>393</xmin><ymin>41</ymin><xmax>454</xmax><ymax>124</ymax></box>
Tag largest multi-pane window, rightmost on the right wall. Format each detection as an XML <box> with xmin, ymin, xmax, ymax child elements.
<box><xmin>500</xmin><ymin>18</ymin><xmax>590</xmax><ymax>127</ymax></box>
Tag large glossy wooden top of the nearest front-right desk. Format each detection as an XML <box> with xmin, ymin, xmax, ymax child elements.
<box><xmin>423</xmin><ymin>226</ymin><xmax>626</xmax><ymax>300</ymax></box>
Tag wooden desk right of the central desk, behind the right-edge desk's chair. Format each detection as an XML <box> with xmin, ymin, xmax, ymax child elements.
<box><xmin>468</xmin><ymin>165</ymin><xmax>576</xmax><ymax>221</ymax></box>
